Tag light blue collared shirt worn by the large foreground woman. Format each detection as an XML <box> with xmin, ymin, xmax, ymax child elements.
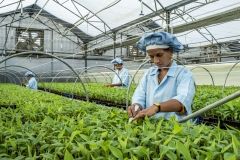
<box><xmin>132</xmin><ymin>61</ymin><xmax>195</xmax><ymax>120</ymax></box>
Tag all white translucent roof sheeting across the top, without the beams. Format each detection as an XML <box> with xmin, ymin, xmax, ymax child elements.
<box><xmin>0</xmin><ymin>0</ymin><xmax>240</xmax><ymax>47</ymax></box>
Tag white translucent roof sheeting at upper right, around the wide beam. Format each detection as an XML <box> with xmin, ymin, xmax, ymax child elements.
<box><xmin>172</xmin><ymin>0</ymin><xmax>240</xmax><ymax>47</ymax></box>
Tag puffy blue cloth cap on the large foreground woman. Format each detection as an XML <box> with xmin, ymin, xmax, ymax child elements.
<box><xmin>136</xmin><ymin>32</ymin><xmax>183</xmax><ymax>52</ymax></box>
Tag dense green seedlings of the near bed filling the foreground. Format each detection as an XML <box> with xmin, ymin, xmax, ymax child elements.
<box><xmin>0</xmin><ymin>84</ymin><xmax>240</xmax><ymax>160</ymax></box>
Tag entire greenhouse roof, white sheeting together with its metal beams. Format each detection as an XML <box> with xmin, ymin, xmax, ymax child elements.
<box><xmin>0</xmin><ymin>0</ymin><xmax>240</xmax><ymax>47</ymax></box>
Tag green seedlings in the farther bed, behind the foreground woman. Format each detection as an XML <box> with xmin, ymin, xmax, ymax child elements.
<box><xmin>39</xmin><ymin>83</ymin><xmax>240</xmax><ymax>122</ymax></box>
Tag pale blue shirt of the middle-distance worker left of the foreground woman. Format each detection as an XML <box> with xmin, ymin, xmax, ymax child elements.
<box><xmin>112</xmin><ymin>67</ymin><xmax>130</xmax><ymax>88</ymax></box>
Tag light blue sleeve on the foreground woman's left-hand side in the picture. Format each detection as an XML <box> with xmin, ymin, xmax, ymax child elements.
<box><xmin>132</xmin><ymin>72</ymin><xmax>148</xmax><ymax>109</ymax></box>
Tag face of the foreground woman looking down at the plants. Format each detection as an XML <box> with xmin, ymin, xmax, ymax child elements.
<box><xmin>147</xmin><ymin>48</ymin><xmax>172</xmax><ymax>68</ymax></box>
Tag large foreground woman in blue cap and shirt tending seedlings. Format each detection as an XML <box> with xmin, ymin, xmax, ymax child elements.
<box><xmin>128</xmin><ymin>32</ymin><xmax>195</xmax><ymax>120</ymax></box>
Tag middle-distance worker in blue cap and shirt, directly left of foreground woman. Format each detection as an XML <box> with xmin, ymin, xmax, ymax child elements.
<box><xmin>105</xmin><ymin>58</ymin><xmax>130</xmax><ymax>88</ymax></box>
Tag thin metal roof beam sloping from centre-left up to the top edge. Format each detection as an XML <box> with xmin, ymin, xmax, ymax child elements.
<box><xmin>89</xmin><ymin>0</ymin><xmax>197</xmax><ymax>41</ymax></box>
